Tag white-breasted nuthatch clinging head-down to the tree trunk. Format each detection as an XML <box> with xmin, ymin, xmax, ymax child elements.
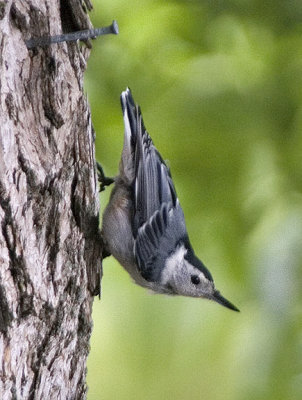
<box><xmin>99</xmin><ymin>88</ymin><xmax>239</xmax><ymax>311</ymax></box>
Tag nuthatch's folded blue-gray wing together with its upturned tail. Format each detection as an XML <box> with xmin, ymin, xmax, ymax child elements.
<box><xmin>121</xmin><ymin>89</ymin><xmax>188</xmax><ymax>282</ymax></box>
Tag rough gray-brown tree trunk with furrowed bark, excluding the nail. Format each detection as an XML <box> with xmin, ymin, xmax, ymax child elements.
<box><xmin>0</xmin><ymin>0</ymin><xmax>101</xmax><ymax>400</ymax></box>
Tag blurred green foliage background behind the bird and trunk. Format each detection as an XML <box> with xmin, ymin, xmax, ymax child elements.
<box><xmin>86</xmin><ymin>0</ymin><xmax>302</xmax><ymax>400</ymax></box>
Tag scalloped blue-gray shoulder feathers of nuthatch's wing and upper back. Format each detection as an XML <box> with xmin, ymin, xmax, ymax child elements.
<box><xmin>134</xmin><ymin>200</ymin><xmax>188</xmax><ymax>282</ymax></box>
